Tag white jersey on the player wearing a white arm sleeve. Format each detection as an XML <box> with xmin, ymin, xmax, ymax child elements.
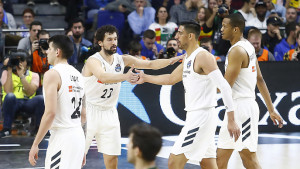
<box><xmin>182</xmin><ymin>47</ymin><xmax>217</xmax><ymax>111</ymax></box>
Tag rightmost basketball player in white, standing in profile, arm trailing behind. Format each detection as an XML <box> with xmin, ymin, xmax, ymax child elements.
<box><xmin>217</xmin><ymin>13</ymin><xmax>283</xmax><ymax>169</ymax></box>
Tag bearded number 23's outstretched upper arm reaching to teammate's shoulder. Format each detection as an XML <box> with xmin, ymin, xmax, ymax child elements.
<box><xmin>122</xmin><ymin>55</ymin><xmax>183</xmax><ymax>69</ymax></box>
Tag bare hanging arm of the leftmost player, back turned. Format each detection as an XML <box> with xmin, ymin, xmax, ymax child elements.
<box><xmin>28</xmin><ymin>70</ymin><xmax>61</xmax><ymax>166</ymax></box>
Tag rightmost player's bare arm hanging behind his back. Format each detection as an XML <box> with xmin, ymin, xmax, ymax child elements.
<box><xmin>256</xmin><ymin>61</ymin><xmax>283</xmax><ymax>128</ymax></box>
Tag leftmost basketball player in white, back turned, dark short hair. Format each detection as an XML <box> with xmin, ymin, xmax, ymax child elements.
<box><xmin>29</xmin><ymin>35</ymin><xmax>85</xmax><ymax>169</ymax></box>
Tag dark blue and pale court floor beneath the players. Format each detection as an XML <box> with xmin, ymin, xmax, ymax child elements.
<box><xmin>0</xmin><ymin>132</ymin><xmax>300</xmax><ymax>169</ymax></box>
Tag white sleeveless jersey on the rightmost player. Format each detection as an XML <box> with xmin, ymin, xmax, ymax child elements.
<box><xmin>225</xmin><ymin>39</ymin><xmax>257</xmax><ymax>99</ymax></box>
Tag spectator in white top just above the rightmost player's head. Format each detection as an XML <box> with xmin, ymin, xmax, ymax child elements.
<box><xmin>238</xmin><ymin>0</ymin><xmax>256</xmax><ymax>25</ymax></box>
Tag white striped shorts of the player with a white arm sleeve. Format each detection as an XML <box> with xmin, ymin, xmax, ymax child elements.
<box><xmin>171</xmin><ymin>107</ymin><xmax>218</xmax><ymax>161</ymax></box>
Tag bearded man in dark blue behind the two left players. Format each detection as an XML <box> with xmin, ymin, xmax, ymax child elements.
<box><xmin>68</xmin><ymin>18</ymin><xmax>92</xmax><ymax>64</ymax></box>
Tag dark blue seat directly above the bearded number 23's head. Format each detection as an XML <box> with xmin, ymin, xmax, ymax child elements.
<box><xmin>97</xmin><ymin>10</ymin><xmax>125</xmax><ymax>33</ymax></box>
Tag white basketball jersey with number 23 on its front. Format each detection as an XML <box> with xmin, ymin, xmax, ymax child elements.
<box><xmin>83</xmin><ymin>52</ymin><xmax>124</xmax><ymax>109</ymax></box>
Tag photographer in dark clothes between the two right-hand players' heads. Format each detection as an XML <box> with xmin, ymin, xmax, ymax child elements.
<box><xmin>202</xmin><ymin>0</ymin><xmax>238</xmax><ymax>57</ymax></box>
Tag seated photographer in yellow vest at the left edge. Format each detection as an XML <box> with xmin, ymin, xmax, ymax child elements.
<box><xmin>0</xmin><ymin>50</ymin><xmax>44</xmax><ymax>138</ymax></box>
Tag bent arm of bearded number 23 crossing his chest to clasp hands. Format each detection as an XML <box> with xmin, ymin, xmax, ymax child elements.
<box><xmin>82</xmin><ymin>58</ymin><xmax>138</xmax><ymax>83</ymax></box>
